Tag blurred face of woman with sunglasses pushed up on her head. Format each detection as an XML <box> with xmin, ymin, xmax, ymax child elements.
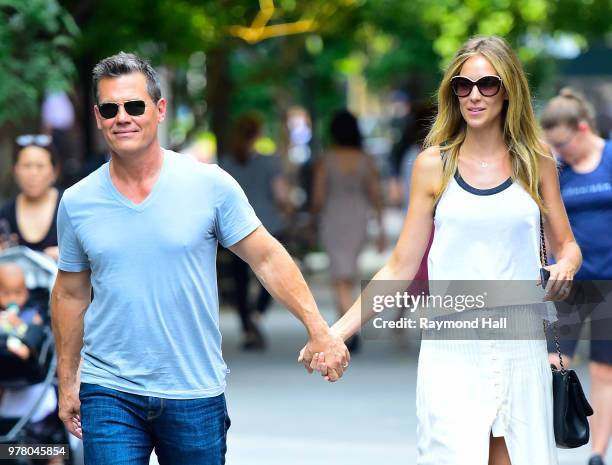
<box><xmin>15</xmin><ymin>145</ymin><xmax>56</xmax><ymax>198</ymax></box>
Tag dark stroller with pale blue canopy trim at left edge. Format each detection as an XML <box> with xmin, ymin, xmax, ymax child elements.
<box><xmin>0</xmin><ymin>247</ymin><xmax>83</xmax><ymax>465</ymax></box>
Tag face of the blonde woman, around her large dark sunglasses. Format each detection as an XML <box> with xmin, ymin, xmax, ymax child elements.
<box><xmin>455</xmin><ymin>54</ymin><xmax>506</xmax><ymax>129</ymax></box>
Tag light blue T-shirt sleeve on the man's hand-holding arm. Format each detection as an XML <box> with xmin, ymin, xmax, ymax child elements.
<box><xmin>215</xmin><ymin>167</ymin><xmax>261</xmax><ymax>248</ymax></box>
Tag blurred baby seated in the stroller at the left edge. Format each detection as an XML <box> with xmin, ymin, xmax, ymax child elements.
<box><xmin>0</xmin><ymin>263</ymin><xmax>45</xmax><ymax>361</ymax></box>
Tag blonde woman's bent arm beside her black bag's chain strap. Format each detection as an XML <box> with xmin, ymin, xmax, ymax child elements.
<box><xmin>540</xmin><ymin>150</ymin><xmax>582</xmax><ymax>300</ymax></box>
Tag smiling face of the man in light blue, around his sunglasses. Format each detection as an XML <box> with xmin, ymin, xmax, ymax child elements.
<box><xmin>94</xmin><ymin>73</ymin><xmax>166</xmax><ymax>157</ymax></box>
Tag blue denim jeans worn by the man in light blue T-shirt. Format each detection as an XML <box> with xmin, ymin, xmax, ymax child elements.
<box><xmin>79</xmin><ymin>383</ymin><xmax>230</xmax><ymax>465</ymax></box>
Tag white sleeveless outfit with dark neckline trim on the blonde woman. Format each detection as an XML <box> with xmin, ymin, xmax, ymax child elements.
<box><xmin>416</xmin><ymin>174</ymin><xmax>558</xmax><ymax>465</ymax></box>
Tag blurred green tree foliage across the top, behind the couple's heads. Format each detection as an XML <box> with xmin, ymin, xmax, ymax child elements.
<box><xmin>53</xmin><ymin>0</ymin><xmax>612</xmax><ymax>156</ymax></box>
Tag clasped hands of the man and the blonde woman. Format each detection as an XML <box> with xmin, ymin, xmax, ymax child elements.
<box><xmin>298</xmin><ymin>326</ymin><xmax>351</xmax><ymax>383</ymax></box>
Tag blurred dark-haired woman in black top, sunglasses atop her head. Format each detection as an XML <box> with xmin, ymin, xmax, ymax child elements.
<box><xmin>0</xmin><ymin>134</ymin><xmax>61</xmax><ymax>260</ymax></box>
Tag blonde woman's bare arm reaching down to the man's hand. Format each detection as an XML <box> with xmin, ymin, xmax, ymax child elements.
<box><xmin>332</xmin><ymin>147</ymin><xmax>442</xmax><ymax>340</ymax></box>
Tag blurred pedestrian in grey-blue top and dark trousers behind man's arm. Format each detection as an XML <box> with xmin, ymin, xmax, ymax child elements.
<box><xmin>219</xmin><ymin>114</ymin><xmax>290</xmax><ymax>350</ymax></box>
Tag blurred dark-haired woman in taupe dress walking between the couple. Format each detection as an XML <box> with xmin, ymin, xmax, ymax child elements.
<box><xmin>311</xmin><ymin>110</ymin><xmax>385</xmax><ymax>352</ymax></box>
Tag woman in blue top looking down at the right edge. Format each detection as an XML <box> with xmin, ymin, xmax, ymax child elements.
<box><xmin>541</xmin><ymin>88</ymin><xmax>612</xmax><ymax>465</ymax></box>
